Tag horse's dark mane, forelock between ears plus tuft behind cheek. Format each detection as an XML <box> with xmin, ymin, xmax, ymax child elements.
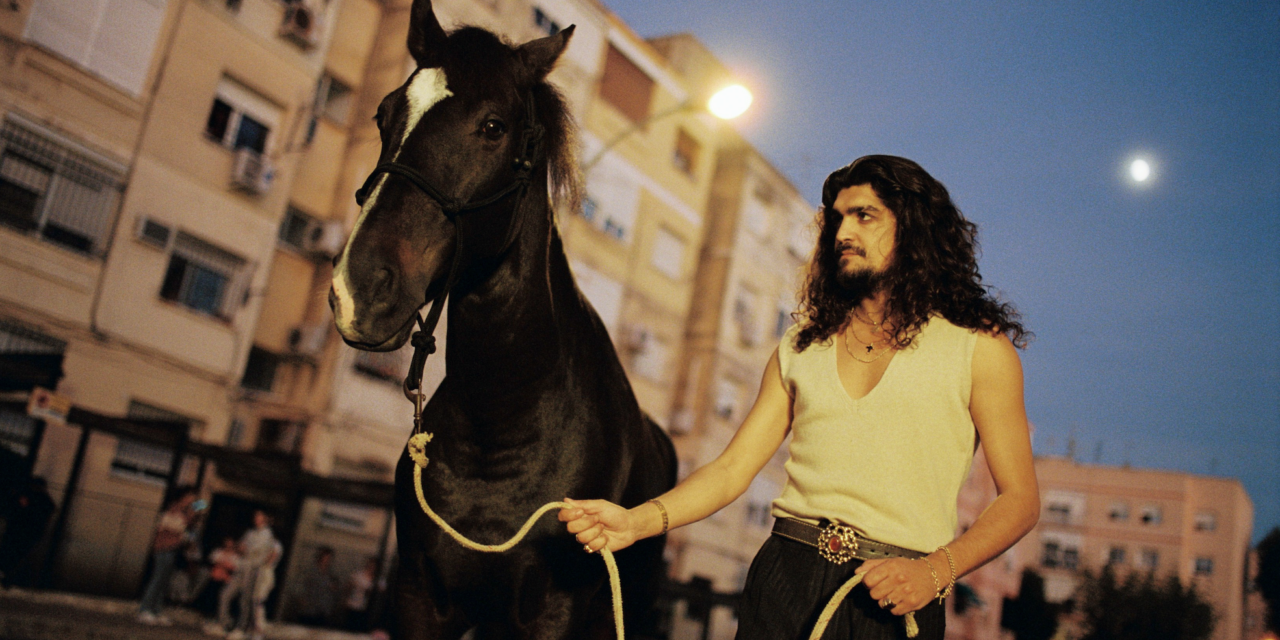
<box><xmin>449</xmin><ymin>26</ymin><xmax>582</xmax><ymax>216</ymax></box>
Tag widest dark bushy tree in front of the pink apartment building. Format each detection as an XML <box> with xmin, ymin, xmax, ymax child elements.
<box><xmin>1080</xmin><ymin>567</ymin><xmax>1215</xmax><ymax>640</ymax></box>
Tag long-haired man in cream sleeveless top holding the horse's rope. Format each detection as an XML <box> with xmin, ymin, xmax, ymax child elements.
<box><xmin>559</xmin><ymin>156</ymin><xmax>1039</xmax><ymax>640</ymax></box>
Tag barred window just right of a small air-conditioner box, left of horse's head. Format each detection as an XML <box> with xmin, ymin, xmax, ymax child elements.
<box><xmin>160</xmin><ymin>232</ymin><xmax>248</xmax><ymax>320</ymax></box>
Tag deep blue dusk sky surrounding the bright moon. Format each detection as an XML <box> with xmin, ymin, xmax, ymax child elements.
<box><xmin>605</xmin><ymin>0</ymin><xmax>1280</xmax><ymax>541</ymax></box>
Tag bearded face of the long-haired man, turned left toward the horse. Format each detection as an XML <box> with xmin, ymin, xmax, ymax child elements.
<box><xmin>833</xmin><ymin>184</ymin><xmax>897</xmax><ymax>282</ymax></box>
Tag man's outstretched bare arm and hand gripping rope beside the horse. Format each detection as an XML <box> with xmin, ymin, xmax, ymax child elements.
<box><xmin>559</xmin><ymin>351</ymin><xmax>791</xmax><ymax>550</ymax></box>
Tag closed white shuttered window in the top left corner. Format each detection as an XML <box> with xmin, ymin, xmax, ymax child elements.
<box><xmin>23</xmin><ymin>0</ymin><xmax>166</xmax><ymax>96</ymax></box>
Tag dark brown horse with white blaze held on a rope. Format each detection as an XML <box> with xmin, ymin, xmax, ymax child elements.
<box><xmin>329</xmin><ymin>0</ymin><xmax>676</xmax><ymax>640</ymax></box>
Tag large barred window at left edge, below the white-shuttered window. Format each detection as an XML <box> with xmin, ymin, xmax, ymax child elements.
<box><xmin>0</xmin><ymin>119</ymin><xmax>124</xmax><ymax>256</ymax></box>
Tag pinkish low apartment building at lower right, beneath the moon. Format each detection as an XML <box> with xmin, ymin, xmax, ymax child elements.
<box><xmin>1028</xmin><ymin>457</ymin><xmax>1253</xmax><ymax>640</ymax></box>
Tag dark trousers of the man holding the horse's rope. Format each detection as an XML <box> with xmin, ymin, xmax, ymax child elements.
<box><xmin>737</xmin><ymin>535</ymin><xmax>946</xmax><ymax>640</ymax></box>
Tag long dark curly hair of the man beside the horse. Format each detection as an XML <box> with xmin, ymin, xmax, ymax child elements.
<box><xmin>795</xmin><ymin>155</ymin><xmax>1033</xmax><ymax>353</ymax></box>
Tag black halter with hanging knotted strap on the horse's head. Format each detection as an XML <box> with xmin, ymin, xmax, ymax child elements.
<box><xmin>356</xmin><ymin>91</ymin><xmax>545</xmax><ymax>404</ymax></box>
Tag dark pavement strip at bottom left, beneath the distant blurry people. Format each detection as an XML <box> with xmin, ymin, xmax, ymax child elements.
<box><xmin>0</xmin><ymin>589</ymin><xmax>370</xmax><ymax>640</ymax></box>
